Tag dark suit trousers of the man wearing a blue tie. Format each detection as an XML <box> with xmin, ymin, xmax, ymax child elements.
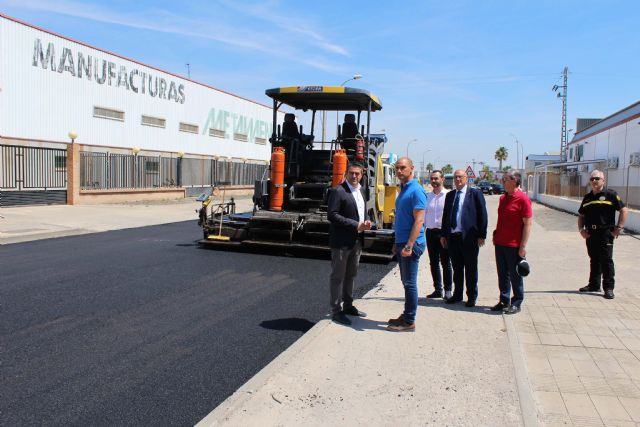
<box><xmin>448</xmin><ymin>233</ymin><xmax>480</xmax><ymax>302</ymax></box>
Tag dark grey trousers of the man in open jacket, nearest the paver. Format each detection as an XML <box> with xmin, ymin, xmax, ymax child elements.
<box><xmin>329</xmin><ymin>239</ymin><xmax>362</xmax><ymax>314</ymax></box>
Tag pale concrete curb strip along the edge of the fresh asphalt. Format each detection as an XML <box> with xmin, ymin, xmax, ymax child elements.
<box><xmin>196</xmin><ymin>319</ymin><xmax>331</xmax><ymax>427</ymax></box>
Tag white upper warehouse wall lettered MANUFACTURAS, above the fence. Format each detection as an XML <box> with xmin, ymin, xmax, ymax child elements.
<box><xmin>0</xmin><ymin>15</ymin><xmax>272</xmax><ymax>160</ymax></box>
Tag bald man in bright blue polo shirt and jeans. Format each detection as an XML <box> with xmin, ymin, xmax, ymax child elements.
<box><xmin>387</xmin><ymin>157</ymin><xmax>427</xmax><ymax>332</ymax></box>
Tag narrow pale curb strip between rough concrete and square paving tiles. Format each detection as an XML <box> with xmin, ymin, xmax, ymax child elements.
<box><xmin>502</xmin><ymin>314</ymin><xmax>541</xmax><ymax>427</ymax></box>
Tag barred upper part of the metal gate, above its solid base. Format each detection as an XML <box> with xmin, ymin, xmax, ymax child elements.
<box><xmin>0</xmin><ymin>145</ymin><xmax>67</xmax><ymax>191</ymax></box>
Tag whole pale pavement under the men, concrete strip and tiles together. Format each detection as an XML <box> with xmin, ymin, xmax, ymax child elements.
<box><xmin>199</xmin><ymin>197</ymin><xmax>640</xmax><ymax>426</ymax></box>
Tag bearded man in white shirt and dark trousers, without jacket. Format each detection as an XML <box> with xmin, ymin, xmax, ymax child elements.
<box><xmin>424</xmin><ymin>170</ymin><xmax>453</xmax><ymax>299</ymax></box>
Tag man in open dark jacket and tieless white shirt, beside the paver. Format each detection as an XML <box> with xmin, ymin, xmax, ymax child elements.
<box><xmin>327</xmin><ymin>162</ymin><xmax>371</xmax><ymax>325</ymax></box>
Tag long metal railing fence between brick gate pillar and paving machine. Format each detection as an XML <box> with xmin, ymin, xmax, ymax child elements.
<box><xmin>80</xmin><ymin>152</ymin><xmax>267</xmax><ymax>190</ymax></box>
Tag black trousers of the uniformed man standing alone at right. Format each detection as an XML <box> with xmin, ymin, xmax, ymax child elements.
<box><xmin>587</xmin><ymin>228</ymin><xmax>615</xmax><ymax>290</ymax></box>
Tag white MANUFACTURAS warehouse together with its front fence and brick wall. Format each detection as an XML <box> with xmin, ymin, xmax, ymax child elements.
<box><xmin>0</xmin><ymin>15</ymin><xmax>284</xmax><ymax>206</ymax></box>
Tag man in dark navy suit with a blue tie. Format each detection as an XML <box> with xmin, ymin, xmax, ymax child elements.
<box><xmin>440</xmin><ymin>169</ymin><xmax>488</xmax><ymax>307</ymax></box>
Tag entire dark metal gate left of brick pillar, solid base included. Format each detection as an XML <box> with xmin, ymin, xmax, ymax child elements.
<box><xmin>0</xmin><ymin>145</ymin><xmax>67</xmax><ymax>207</ymax></box>
